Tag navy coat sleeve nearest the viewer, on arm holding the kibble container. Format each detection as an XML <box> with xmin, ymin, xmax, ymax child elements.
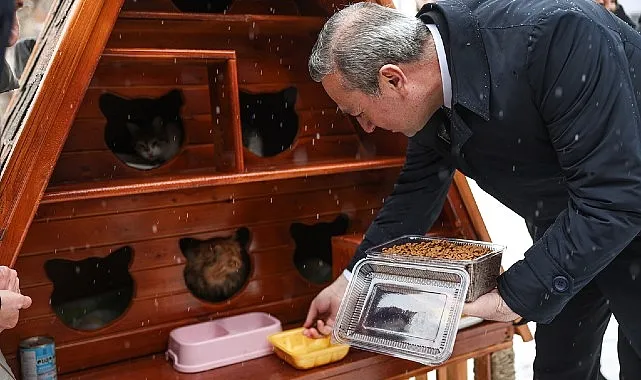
<box><xmin>498</xmin><ymin>13</ymin><xmax>641</xmax><ymax>323</ymax></box>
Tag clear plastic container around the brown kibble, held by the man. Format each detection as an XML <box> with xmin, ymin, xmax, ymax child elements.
<box><xmin>367</xmin><ymin>235</ymin><xmax>505</xmax><ymax>302</ymax></box>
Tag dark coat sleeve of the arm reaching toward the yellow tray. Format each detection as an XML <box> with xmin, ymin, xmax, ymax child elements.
<box><xmin>347</xmin><ymin>123</ymin><xmax>454</xmax><ymax>271</ymax></box>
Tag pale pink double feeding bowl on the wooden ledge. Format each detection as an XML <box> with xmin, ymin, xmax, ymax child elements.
<box><xmin>166</xmin><ymin>313</ymin><xmax>282</xmax><ymax>373</ymax></box>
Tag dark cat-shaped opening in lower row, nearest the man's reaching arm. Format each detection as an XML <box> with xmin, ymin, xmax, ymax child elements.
<box><xmin>290</xmin><ymin>214</ymin><xmax>349</xmax><ymax>284</ymax></box>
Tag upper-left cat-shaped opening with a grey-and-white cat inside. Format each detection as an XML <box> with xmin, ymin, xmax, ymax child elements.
<box><xmin>100</xmin><ymin>90</ymin><xmax>185</xmax><ymax>170</ymax></box>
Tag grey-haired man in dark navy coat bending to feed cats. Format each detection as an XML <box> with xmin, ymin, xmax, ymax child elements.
<box><xmin>305</xmin><ymin>0</ymin><xmax>641</xmax><ymax>380</ymax></box>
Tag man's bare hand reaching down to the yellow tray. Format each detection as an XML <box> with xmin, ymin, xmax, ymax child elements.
<box><xmin>303</xmin><ymin>274</ymin><xmax>348</xmax><ymax>338</ymax></box>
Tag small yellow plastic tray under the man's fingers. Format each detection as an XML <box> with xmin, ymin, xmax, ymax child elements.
<box><xmin>269</xmin><ymin>327</ymin><xmax>349</xmax><ymax>369</ymax></box>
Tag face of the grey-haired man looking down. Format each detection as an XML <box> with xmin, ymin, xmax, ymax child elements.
<box><xmin>322</xmin><ymin>74</ymin><xmax>424</xmax><ymax>137</ymax></box>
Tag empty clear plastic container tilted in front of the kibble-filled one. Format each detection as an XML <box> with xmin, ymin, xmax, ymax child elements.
<box><xmin>332</xmin><ymin>257</ymin><xmax>470</xmax><ymax>366</ymax></box>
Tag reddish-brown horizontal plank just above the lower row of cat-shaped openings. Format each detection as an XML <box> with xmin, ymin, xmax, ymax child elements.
<box><xmin>25</xmin><ymin>186</ymin><xmax>387</xmax><ymax>252</ymax></box>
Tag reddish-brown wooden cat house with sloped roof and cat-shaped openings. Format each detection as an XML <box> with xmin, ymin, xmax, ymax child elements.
<box><xmin>0</xmin><ymin>0</ymin><xmax>528</xmax><ymax>379</ymax></box>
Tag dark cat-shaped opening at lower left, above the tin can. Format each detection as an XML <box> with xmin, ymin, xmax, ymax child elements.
<box><xmin>44</xmin><ymin>247</ymin><xmax>134</xmax><ymax>330</ymax></box>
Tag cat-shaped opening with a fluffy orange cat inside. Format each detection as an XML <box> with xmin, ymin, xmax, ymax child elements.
<box><xmin>179</xmin><ymin>227</ymin><xmax>251</xmax><ymax>302</ymax></box>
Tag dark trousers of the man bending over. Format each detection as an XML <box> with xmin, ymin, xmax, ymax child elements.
<box><xmin>534</xmin><ymin>237</ymin><xmax>641</xmax><ymax>380</ymax></box>
